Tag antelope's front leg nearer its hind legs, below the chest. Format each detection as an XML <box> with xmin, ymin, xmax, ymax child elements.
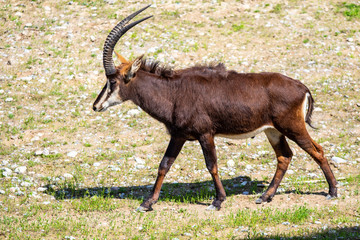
<box><xmin>199</xmin><ymin>134</ymin><xmax>226</xmax><ymax>210</ymax></box>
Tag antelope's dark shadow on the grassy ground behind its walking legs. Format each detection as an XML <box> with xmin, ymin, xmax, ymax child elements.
<box><xmin>46</xmin><ymin>176</ymin><xmax>265</xmax><ymax>204</ymax></box>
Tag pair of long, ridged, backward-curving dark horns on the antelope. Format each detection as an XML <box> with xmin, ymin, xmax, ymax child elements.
<box><xmin>103</xmin><ymin>4</ymin><xmax>152</xmax><ymax>76</ymax></box>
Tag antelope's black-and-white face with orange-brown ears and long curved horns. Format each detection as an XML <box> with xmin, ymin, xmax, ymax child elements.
<box><xmin>93</xmin><ymin>5</ymin><xmax>152</xmax><ymax>112</ymax></box>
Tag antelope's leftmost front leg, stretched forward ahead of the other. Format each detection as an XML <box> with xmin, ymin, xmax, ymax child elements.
<box><xmin>137</xmin><ymin>137</ymin><xmax>185</xmax><ymax>212</ymax></box>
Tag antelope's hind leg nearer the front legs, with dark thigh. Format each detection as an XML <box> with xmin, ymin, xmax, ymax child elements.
<box><xmin>255</xmin><ymin>128</ymin><xmax>293</xmax><ymax>204</ymax></box>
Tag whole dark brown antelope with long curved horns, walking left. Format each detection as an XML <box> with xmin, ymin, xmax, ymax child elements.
<box><xmin>93</xmin><ymin>5</ymin><xmax>337</xmax><ymax>211</ymax></box>
